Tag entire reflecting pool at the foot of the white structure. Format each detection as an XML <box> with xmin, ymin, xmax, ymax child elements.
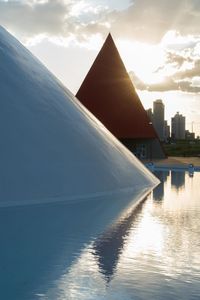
<box><xmin>0</xmin><ymin>171</ymin><xmax>200</xmax><ymax>300</ymax></box>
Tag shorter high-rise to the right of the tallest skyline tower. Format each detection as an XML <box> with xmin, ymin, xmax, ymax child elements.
<box><xmin>171</xmin><ymin>112</ymin><xmax>185</xmax><ymax>140</ymax></box>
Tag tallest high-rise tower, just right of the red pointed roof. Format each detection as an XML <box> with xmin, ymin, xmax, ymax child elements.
<box><xmin>153</xmin><ymin>99</ymin><xmax>165</xmax><ymax>141</ymax></box>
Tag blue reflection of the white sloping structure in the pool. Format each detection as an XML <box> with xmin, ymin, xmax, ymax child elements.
<box><xmin>0</xmin><ymin>192</ymin><xmax>146</xmax><ymax>300</ymax></box>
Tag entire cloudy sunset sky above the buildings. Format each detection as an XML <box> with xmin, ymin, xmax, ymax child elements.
<box><xmin>0</xmin><ymin>0</ymin><xmax>200</xmax><ymax>135</ymax></box>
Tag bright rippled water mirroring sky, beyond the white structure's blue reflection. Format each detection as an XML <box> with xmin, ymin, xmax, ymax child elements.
<box><xmin>47</xmin><ymin>173</ymin><xmax>200</xmax><ymax>300</ymax></box>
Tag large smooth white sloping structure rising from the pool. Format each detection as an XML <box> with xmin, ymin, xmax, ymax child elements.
<box><xmin>0</xmin><ymin>27</ymin><xmax>158</xmax><ymax>206</ymax></box>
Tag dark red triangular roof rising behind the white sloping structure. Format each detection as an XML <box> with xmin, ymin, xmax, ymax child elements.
<box><xmin>76</xmin><ymin>34</ymin><xmax>157</xmax><ymax>138</ymax></box>
